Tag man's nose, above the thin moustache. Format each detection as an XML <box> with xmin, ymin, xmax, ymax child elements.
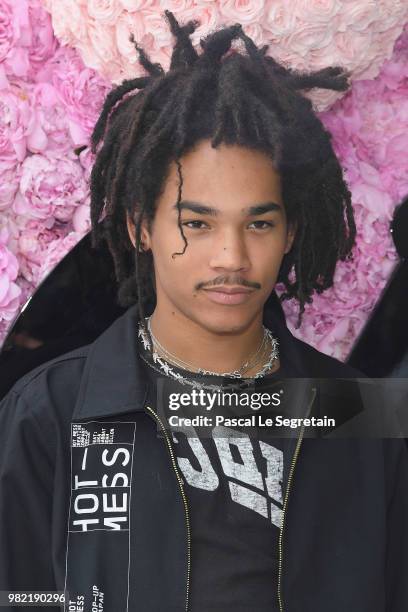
<box><xmin>209</xmin><ymin>230</ymin><xmax>250</xmax><ymax>272</ymax></box>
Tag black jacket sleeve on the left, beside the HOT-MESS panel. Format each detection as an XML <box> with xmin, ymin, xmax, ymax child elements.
<box><xmin>0</xmin><ymin>389</ymin><xmax>56</xmax><ymax>592</ymax></box>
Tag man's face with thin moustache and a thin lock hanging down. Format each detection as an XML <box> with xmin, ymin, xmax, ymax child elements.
<box><xmin>128</xmin><ymin>140</ymin><xmax>294</xmax><ymax>333</ymax></box>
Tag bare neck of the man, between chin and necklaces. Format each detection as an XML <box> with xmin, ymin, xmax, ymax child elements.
<box><xmin>150</xmin><ymin>307</ymin><xmax>264</xmax><ymax>372</ymax></box>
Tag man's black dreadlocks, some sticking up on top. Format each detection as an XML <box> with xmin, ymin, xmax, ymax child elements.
<box><xmin>91</xmin><ymin>11</ymin><xmax>356</xmax><ymax>327</ymax></box>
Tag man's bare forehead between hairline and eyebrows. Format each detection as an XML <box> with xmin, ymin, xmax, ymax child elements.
<box><xmin>158</xmin><ymin>140</ymin><xmax>281</xmax><ymax>206</ymax></box>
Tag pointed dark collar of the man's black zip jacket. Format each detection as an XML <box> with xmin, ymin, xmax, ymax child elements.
<box><xmin>73</xmin><ymin>305</ymin><xmax>307</xmax><ymax>420</ymax></box>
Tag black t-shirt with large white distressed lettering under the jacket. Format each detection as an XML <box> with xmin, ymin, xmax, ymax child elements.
<box><xmin>139</xmin><ymin>332</ymin><xmax>287</xmax><ymax>612</ymax></box>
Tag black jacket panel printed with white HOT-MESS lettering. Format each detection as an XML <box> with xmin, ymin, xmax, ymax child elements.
<box><xmin>64</xmin><ymin>421</ymin><xmax>136</xmax><ymax>612</ymax></box>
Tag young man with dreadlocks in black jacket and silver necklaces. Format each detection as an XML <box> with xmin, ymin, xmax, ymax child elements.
<box><xmin>0</xmin><ymin>12</ymin><xmax>408</xmax><ymax>612</ymax></box>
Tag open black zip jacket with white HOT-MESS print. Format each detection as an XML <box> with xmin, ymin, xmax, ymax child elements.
<box><xmin>0</xmin><ymin>307</ymin><xmax>408</xmax><ymax>612</ymax></box>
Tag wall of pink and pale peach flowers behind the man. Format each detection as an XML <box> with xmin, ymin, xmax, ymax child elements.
<box><xmin>0</xmin><ymin>0</ymin><xmax>408</xmax><ymax>360</ymax></box>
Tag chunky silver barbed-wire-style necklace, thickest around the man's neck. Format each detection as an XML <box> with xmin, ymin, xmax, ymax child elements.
<box><xmin>138</xmin><ymin>317</ymin><xmax>279</xmax><ymax>388</ymax></box>
